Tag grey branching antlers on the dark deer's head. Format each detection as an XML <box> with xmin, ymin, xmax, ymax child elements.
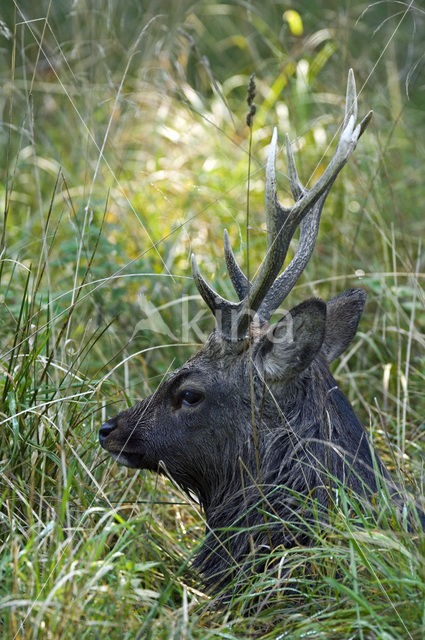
<box><xmin>192</xmin><ymin>69</ymin><xmax>372</xmax><ymax>340</ymax></box>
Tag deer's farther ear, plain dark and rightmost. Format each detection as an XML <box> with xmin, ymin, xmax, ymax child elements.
<box><xmin>321</xmin><ymin>289</ymin><xmax>367</xmax><ymax>364</ymax></box>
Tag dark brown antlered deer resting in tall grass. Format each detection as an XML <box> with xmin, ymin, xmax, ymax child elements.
<box><xmin>99</xmin><ymin>69</ymin><xmax>410</xmax><ymax>592</ymax></box>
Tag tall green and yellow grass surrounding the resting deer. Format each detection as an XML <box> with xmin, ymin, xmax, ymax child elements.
<box><xmin>0</xmin><ymin>0</ymin><xmax>425</xmax><ymax>640</ymax></box>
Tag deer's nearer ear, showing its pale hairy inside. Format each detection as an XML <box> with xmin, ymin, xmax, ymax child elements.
<box><xmin>256</xmin><ymin>298</ymin><xmax>326</xmax><ymax>380</ymax></box>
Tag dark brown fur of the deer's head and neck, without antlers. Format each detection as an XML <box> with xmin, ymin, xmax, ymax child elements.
<box><xmin>100</xmin><ymin>290</ymin><xmax>398</xmax><ymax>588</ymax></box>
